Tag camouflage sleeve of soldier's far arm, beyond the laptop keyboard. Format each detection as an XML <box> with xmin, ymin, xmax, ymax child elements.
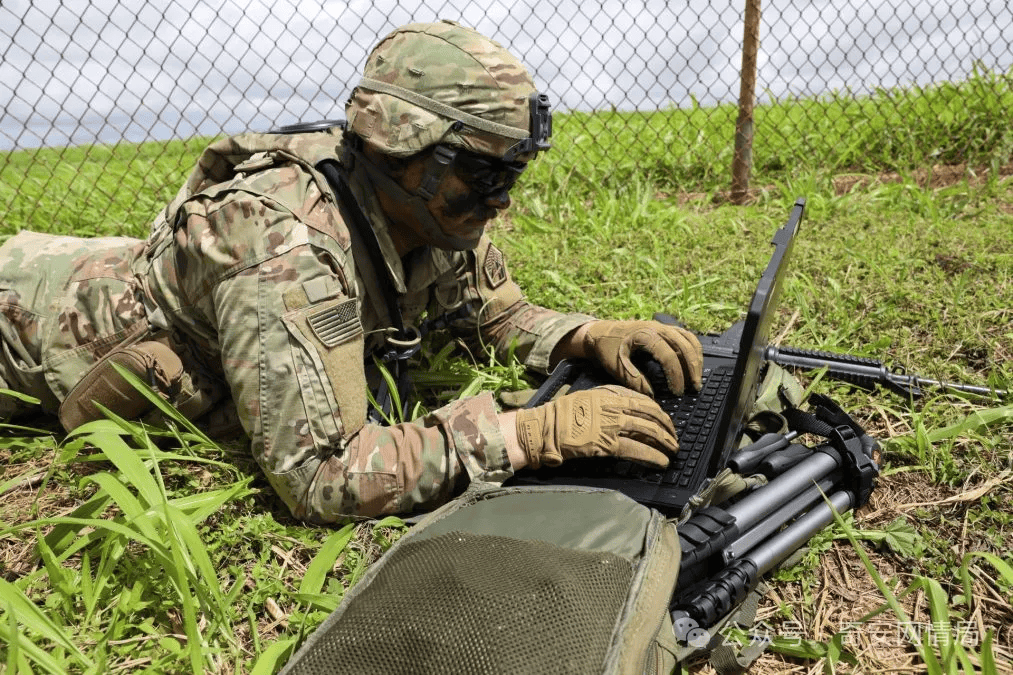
<box><xmin>438</xmin><ymin>237</ymin><xmax>594</xmax><ymax>373</ymax></box>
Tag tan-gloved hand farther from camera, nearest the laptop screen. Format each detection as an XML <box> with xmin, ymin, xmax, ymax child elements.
<box><xmin>583</xmin><ymin>321</ymin><xmax>703</xmax><ymax>396</ymax></box>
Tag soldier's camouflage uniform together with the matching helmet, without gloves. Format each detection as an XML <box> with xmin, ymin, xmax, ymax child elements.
<box><xmin>0</xmin><ymin>22</ymin><xmax>591</xmax><ymax>514</ymax></box>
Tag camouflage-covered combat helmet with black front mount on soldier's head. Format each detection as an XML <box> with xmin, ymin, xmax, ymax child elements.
<box><xmin>345</xmin><ymin>20</ymin><xmax>551</xmax><ymax>160</ymax></box>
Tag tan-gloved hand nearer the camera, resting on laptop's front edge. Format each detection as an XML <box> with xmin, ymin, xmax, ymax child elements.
<box><xmin>517</xmin><ymin>385</ymin><xmax>679</xmax><ymax>468</ymax></box>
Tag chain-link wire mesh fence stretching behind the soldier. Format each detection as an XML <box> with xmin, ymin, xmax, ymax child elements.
<box><xmin>0</xmin><ymin>0</ymin><xmax>1013</xmax><ymax>230</ymax></box>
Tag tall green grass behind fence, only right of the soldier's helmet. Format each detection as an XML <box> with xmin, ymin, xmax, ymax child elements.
<box><xmin>530</xmin><ymin>64</ymin><xmax>1013</xmax><ymax>193</ymax></box>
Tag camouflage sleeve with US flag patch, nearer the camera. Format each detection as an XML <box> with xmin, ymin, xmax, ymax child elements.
<box><xmin>177</xmin><ymin>186</ymin><xmax>510</xmax><ymax>522</ymax></box>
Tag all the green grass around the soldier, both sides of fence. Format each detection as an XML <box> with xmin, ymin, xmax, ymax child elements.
<box><xmin>0</xmin><ymin>74</ymin><xmax>1013</xmax><ymax>673</ymax></box>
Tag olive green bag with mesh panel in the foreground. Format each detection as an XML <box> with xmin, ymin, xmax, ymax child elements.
<box><xmin>282</xmin><ymin>485</ymin><xmax>680</xmax><ymax>675</ymax></box>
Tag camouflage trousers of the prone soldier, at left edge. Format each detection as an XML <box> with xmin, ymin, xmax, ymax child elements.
<box><xmin>0</xmin><ymin>232</ymin><xmax>224</xmax><ymax>423</ymax></box>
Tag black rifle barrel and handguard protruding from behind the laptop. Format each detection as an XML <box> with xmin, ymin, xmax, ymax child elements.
<box><xmin>764</xmin><ymin>346</ymin><xmax>1010</xmax><ymax>400</ymax></box>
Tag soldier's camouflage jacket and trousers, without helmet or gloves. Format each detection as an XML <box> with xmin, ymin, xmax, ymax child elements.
<box><xmin>0</xmin><ymin>126</ymin><xmax>591</xmax><ymax>522</ymax></box>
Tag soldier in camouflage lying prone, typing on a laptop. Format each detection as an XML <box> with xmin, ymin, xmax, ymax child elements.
<box><xmin>0</xmin><ymin>21</ymin><xmax>702</xmax><ymax>516</ymax></box>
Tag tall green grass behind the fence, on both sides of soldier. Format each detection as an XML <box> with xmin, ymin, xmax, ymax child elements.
<box><xmin>0</xmin><ymin>69</ymin><xmax>1013</xmax><ymax>231</ymax></box>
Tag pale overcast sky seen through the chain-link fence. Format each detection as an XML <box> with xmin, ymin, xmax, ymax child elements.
<box><xmin>0</xmin><ymin>0</ymin><xmax>1013</xmax><ymax>149</ymax></box>
